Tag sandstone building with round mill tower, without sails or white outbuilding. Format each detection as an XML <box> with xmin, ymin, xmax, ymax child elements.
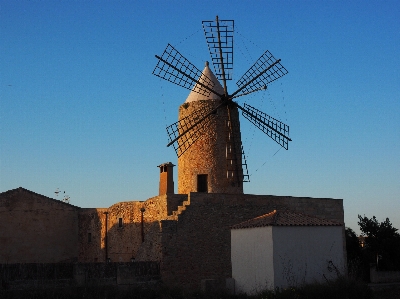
<box><xmin>0</xmin><ymin>66</ymin><xmax>344</xmax><ymax>289</ymax></box>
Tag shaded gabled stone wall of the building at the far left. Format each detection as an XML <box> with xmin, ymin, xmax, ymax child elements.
<box><xmin>0</xmin><ymin>188</ymin><xmax>80</xmax><ymax>263</ymax></box>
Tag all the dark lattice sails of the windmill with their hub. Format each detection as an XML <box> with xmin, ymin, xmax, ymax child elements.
<box><xmin>153</xmin><ymin>16</ymin><xmax>292</xmax><ymax>190</ymax></box>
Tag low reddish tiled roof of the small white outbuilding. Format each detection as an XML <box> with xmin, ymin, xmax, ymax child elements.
<box><xmin>231</xmin><ymin>210</ymin><xmax>342</xmax><ymax>229</ymax></box>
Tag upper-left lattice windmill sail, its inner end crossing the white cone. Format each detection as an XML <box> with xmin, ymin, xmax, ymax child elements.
<box><xmin>153</xmin><ymin>44</ymin><xmax>214</xmax><ymax>96</ymax></box>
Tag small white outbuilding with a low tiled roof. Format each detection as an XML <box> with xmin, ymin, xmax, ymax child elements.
<box><xmin>231</xmin><ymin>210</ymin><xmax>345</xmax><ymax>294</ymax></box>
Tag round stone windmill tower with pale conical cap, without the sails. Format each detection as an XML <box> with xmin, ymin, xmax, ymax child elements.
<box><xmin>178</xmin><ymin>62</ymin><xmax>245</xmax><ymax>194</ymax></box>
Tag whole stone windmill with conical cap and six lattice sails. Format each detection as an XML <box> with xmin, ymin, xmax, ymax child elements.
<box><xmin>153</xmin><ymin>16</ymin><xmax>291</xmax><ymax>193</ymax></box>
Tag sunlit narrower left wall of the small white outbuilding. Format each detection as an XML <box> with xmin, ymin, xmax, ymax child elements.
<box><xmin>231</xmin><ymin>226</ymin><xmax>274</xmax><ymax>294</ymax></box>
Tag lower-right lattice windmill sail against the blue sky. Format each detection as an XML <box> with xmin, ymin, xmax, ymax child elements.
<box><xmin>236</xmin><ymin>104</ymin><xmax>292</xmax><ymax>150</ymax></box>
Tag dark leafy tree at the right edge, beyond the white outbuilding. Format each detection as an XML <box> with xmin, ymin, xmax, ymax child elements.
<box><xmin>358</xmin><ymin>215</ymin><xmax>400</xmax><ymax>270</ymax></box>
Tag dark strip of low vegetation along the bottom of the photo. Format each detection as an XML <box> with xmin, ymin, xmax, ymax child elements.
<box><xmin>0</xmin><ymin>277</ymin><xmax>373</xmax><ymax>299</ymax></box>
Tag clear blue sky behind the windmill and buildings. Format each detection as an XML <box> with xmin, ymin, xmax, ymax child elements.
<box><xmin>0</xmin><ymin>0</ymin><xmax>400</xmax><ymax>231</ymax></box>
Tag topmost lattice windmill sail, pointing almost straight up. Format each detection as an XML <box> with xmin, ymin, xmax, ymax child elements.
<box><xmin>202</xmin><ymin>19</ymin><xmax>234</xmax><ymax>80</ymax></box>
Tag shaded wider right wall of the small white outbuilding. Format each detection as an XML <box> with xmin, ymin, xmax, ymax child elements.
<box><xmin>273</xmin><ymin>226</ymin><xmax>344</xmax><ymax>288</ymax></box>
